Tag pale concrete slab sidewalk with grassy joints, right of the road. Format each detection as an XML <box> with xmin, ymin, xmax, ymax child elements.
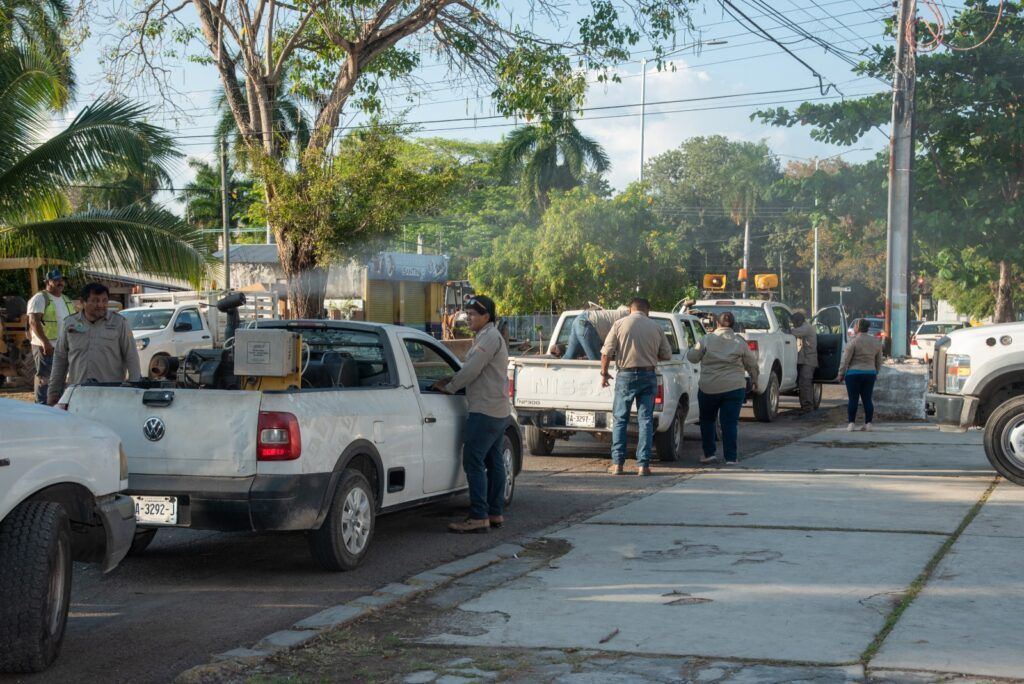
<box><xmin>409</xmin><ymin>424</ymin><xmax>1024</xmax><ymax>682</ymax></box>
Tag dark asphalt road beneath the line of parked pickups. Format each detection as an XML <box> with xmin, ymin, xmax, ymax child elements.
<box><xmin>0</xmin><ymin>388</ymin><xmax>840</xmax><ymax>684</ymax></box>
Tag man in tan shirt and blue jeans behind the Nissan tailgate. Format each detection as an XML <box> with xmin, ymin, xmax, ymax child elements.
<box><xmin>601</xmin><ymin>297</ymin><xmax>672</xmax><ymax>476</ymax></box>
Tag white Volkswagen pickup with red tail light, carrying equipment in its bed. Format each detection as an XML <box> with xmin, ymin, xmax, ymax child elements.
<box><xmin>60</xmin><ymin>320</ymin><xmax>522</xmax><ymax>570</ymax></box>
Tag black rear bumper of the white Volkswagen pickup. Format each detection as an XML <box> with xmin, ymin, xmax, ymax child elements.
<box><xmin>127</xmin><ymin>473</ymin><xmax>331</xmax><ymax>531</ymax></box>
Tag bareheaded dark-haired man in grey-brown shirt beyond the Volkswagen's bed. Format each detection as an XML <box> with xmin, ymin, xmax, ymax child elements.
<box><xmin>46</xmin><ymin>283</ymin><xmax>142</xmax><ymax>407</ymax></box>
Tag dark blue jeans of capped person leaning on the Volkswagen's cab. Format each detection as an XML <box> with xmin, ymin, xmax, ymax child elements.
<box><xmin>462</xmin><ymin>414</ymin><xmax>509</xmax><ymax>520</ymax></box>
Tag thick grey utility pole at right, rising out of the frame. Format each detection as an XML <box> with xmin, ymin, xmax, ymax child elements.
<box><xmin>885</xmin><ymin>0</ymin><xmax>918</xmax><ymax>357</ymax></box>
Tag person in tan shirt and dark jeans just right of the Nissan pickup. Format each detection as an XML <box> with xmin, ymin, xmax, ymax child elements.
<box><xmin>686</xmin><ymin>311</ymin><xmax>758</xmax><ymax>465</ymax></box>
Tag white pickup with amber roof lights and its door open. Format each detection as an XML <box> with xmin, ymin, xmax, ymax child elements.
<box><xmin>681</xmin><ymin>299</ymin><xmax>846</xmax><ymax>423</ymax></box>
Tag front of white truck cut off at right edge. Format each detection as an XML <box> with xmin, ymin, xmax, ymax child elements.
<box><xmin>925</xmin><ymin>323</ymin><xmax>1024</xmax><ymax>485</ymax></box>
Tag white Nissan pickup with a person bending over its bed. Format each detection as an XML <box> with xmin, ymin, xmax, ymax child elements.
<box><xmin>509</xmin><ymin>311</ymin><xmax>705</xmax><ymax>461</ymax></box>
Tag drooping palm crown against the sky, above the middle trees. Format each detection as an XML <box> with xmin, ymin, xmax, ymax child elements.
<box><xmin>497</xmin><ymin>114</ymin><xmax>611</xmax><ymax>212</ymax></box>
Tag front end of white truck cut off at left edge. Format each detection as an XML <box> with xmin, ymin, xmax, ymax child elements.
<box><xmin>0</xmin><ymin>399</ymin><xmax>135</xmax><ymax>673</ymax></box>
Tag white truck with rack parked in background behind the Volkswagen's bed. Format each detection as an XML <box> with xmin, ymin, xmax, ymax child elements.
<box><xmin>121</xmin><ymin>292</ymin><xmax>280</xmax><ymax>377</ymax></box>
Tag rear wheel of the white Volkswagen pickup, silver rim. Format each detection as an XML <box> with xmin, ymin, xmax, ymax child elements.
<box><xmin>309</xmin><ymin>468</ymin><xmax>377</xmax><ymax>571</ymax></box>
